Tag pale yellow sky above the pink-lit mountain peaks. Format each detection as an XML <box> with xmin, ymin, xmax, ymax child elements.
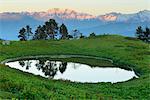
<box><xmin>0</xmin><ymin>0</ymin><xmax>150</xmax><ymax>15</ymax></box>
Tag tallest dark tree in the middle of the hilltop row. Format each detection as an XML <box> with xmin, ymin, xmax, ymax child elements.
<box><xmin>43</xmin><ymin>19</ymin><xmax>58</xmax><ymax>39</ymax></box>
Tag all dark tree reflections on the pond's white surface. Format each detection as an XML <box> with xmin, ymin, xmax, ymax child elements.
<box><xmin>19</xmin><ymin>60</ymin><xmax>67</xmax><ymax>78</ymax></box>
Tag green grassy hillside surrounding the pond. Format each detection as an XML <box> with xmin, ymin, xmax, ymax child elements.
<box><xmin>0</xmin><ymin>36</ymin><xmax>150</xmax><ymax>99</ymax></box>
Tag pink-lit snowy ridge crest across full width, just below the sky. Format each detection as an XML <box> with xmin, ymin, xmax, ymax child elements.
<box><xmin>0</xmin><ymin>8</ymin><xmax>150</xmax><ymax>21</ymax></box>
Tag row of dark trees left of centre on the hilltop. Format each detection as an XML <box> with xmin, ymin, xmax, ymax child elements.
<box><xmin>18</xmin><ymin>19</ymin><xmax>85</xmax><ymax>41</ymax></box>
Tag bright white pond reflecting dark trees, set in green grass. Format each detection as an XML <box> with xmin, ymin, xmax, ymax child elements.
<box><xmin>5</xmin><ymin>59</ymin><xmax>137</xmax><ymax>83</ymax></box>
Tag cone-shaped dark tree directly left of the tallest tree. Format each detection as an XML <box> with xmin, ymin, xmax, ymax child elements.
<box><xmin>33</xmin><ymin>25</ymin><xmax>47</xmax><ymax>40</ymax></box>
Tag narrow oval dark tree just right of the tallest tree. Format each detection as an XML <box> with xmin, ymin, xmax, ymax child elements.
<box><xmin>59</xmin><ymin>24</ymin><xmax>68</xmax><ymax>39</ymax></box>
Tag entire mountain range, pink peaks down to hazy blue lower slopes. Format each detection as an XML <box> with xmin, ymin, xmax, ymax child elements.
<box><xmin>0</xmin><ymin>8</ymin><xmax>150</xmax><ymax>40</ymax></box>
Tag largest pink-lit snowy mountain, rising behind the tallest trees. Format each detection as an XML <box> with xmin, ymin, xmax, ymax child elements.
<box><xmin>0</xmin><ymin>8</ymin><xmax>96</xmax><ymax>20</ymax></box>
